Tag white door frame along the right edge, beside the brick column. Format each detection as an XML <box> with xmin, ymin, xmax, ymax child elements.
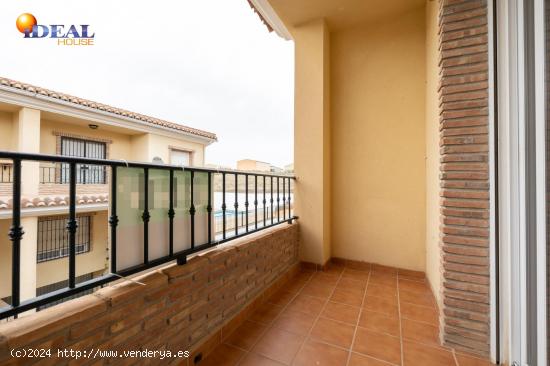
<box><xmin>496</xmin><ymin>0</ymin><xmax>547</xmax><ymax>366</ymax></box>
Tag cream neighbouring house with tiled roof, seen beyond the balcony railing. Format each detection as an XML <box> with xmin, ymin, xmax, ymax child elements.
<box><xmin>0</xmin><ymin>78</ymin><xmax>217</xmax><ymax>302</ymax></box>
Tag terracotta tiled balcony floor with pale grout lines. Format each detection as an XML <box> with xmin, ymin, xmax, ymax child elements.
<box><xmin>201</xmin><ymin>266</ymin><xmax>496</xmax><ymax>366</ymax></box>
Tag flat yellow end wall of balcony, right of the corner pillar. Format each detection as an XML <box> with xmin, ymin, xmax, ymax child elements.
<box><xmin>330</xmin><ymin>7</ymin><xmax>426</xmax><ymax>271</ymax></box>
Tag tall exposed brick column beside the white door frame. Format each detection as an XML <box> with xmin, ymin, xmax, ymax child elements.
<box><xmin>439</xmin><ymin>0</ymin><xmax>490</xmax><ymax>355</ymax></box>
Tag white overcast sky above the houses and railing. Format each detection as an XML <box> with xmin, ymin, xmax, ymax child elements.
<box><xmin>0</xmin><ymin>0</ymin><xmax>294</xmax><ymax>167</ymax></box>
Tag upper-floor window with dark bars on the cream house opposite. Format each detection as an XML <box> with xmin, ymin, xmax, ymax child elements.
<box><xmin>61</xmin><ymin>137</ymin><xmax>107</xmax><ymax>184</ymax></box>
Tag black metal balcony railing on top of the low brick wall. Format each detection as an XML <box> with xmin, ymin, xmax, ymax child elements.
<box><xmin>0</xmin><ymin>151</ymin><xmax>297</xmax><ymax>319</ymax></box>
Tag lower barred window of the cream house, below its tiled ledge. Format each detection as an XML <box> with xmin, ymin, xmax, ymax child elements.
<box><xmin>36</xmin><ymin>216</ymin><xmax>92</xmax><ymax>262</ymax></box>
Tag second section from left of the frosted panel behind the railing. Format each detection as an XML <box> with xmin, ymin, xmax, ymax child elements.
<box><xmin>149</xmin><ymin>169</ymin><xmax>170</xmax><ymax>260</ymax></box>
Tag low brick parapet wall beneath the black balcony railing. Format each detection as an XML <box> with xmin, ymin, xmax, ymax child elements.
<box><xmin>0</xmin><ymin>224</ymin><xmax>299</xmax><ymax>365</ymax></box>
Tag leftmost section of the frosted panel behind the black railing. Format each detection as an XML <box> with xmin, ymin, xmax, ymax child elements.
<box><xmin>117</xmin><ymin>168</ymin><xmax>144</xmax><ymax>271</ymax></box>
